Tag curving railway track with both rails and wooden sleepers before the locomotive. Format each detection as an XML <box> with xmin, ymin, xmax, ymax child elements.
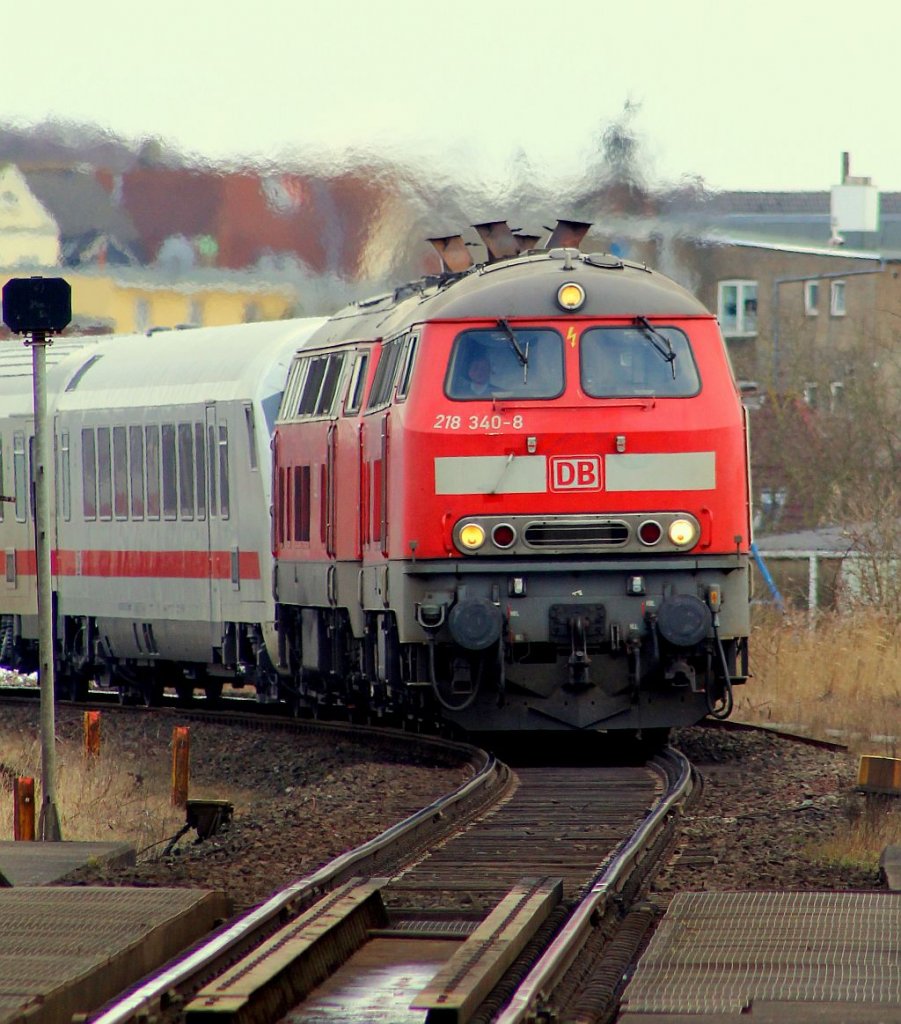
<box><xmin>80</xmin><ymin>737</ymin><xmax>690</xmax><ymax>1024</ymax></box>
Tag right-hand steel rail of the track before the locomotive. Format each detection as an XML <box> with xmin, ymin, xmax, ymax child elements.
<box><xmin>494</xmin><ymin>748</ymin><xmax>692</xmax><ymax>1024</ymax></box>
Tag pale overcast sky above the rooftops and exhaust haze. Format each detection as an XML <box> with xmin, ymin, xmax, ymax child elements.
<box><xmin>7</xmin><ymin>0</ymin><xmax>901</xmax><ymax>190</ymax></box>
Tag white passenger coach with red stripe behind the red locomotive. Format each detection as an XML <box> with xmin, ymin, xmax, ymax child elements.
<box><xmin>0</xmin><ymin>319</ymin><xmax>324</xmax><ymax>701</ymax></box>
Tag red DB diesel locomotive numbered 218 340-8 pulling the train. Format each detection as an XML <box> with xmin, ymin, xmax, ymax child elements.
<box><xmin>272</xmin><ymin>221</ymin><xmax>752</xmax><ymax>731</ymax></box>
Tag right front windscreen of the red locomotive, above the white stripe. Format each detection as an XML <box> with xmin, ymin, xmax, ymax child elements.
<box><xmin>580</xmin><ymin>326</ymin><xmax>700</xmax><ymax>398</ymax></box>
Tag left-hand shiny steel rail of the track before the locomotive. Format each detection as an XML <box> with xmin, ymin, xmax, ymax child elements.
<box><xmin>90</xmin><ymin>744</ymin><xmax>507</xmax><ymax>1024</ymax></box>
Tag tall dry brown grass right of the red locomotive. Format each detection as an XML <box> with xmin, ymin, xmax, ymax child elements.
<box><xmin>734</xmin><ymin>609</ymin><xmax>901</xmax><ymax>757</ymax></box>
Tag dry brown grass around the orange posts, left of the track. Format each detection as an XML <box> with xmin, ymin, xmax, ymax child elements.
<box><xmin>0</xmin><ymin>728</ymin><xmax>246</xmax><ymax>857</ymax></box>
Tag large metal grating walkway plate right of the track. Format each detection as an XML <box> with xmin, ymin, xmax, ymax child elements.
<box><xmin>623</xmin><ymin>892</ymin><xmax>901</xmax><ymax>1021</ymax></box>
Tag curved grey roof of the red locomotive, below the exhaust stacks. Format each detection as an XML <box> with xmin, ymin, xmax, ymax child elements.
<box><xmin>313</xmin><ymin>249</ymin><xmax>711</xmax><ymax>344</ymax></box>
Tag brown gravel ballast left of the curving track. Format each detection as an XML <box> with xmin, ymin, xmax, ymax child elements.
<box><xmin>0</xmin><ymin>703</ymin><xmax>472</xmax><ymax>911</ymax></box>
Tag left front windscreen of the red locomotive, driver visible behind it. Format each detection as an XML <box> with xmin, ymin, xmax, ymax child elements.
<box><xmin>444</xmin><ymin>324</ymin><xmax>564</xmax><ymax>401</ymax></box>
